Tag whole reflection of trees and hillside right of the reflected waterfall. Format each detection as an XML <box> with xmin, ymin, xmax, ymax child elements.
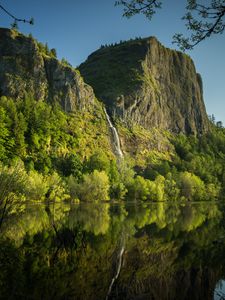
<box><xmin>114</xmin><ymin>203</ymin><xmax>225</xmax><ymax>299</ymax></box>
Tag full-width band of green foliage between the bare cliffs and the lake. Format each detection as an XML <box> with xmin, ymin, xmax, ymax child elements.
<box><xmin>0</xmin><ymin>95</ymin><xmax>225</xmax><ymax>203</ymax></box>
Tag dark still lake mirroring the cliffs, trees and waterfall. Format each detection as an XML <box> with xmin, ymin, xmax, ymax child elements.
<box><xmin>0</xmin><ymin>202</ymin><xmax>225</xmax><ymax>300</ymax></box>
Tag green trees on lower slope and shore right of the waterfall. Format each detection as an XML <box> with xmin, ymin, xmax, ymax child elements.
<box><xmin>123</xmin><ymin>126</ymin><xmax>225</xmax><ymax>201</ymax></box>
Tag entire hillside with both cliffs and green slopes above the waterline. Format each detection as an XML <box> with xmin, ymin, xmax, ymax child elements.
<box><xmin>0</xmin><ymin>29</ymin><xmax>225</xmax><ymax>204</ymax></box>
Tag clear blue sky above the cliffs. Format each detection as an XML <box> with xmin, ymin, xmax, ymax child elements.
<box><xmin>0</xmin><ymin>0</ymin><xmax>225</xmax><ymax>125</ymax></box>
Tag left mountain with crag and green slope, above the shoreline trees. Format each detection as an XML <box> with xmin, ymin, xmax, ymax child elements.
<box><xmin>0</xmin><ymin>28</ymin><xmax>114</xmax><ymax>166</ymax></box>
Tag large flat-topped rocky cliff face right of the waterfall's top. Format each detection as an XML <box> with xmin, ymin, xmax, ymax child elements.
<box><xmin>79</xmin><ymin>37</ymin><xmax>209</xmax><ymax>134</ymax></box>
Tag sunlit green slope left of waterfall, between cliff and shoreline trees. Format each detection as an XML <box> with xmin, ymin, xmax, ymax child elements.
<box><xmin>0</xmin><ymin>95</ymin><xmax>112</xmax><ymax>173</ymax></box>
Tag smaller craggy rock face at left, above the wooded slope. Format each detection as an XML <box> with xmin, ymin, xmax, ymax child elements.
<box><xmin>0</xmin><ymin>28</ymin><xmax>94</xmax><ymax>112</ymax></box>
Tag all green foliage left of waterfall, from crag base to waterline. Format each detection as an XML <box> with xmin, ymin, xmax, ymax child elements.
<box><xmin>0</xmin><ymin>95</ymin><xmax>116</xmax><ymax>205</ymax></box>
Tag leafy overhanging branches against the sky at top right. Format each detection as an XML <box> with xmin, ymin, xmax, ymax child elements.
<box><xmin>115</xmin><ymin>0</ymin><xmax>225</xmax><ymax>51</ymax></box>
